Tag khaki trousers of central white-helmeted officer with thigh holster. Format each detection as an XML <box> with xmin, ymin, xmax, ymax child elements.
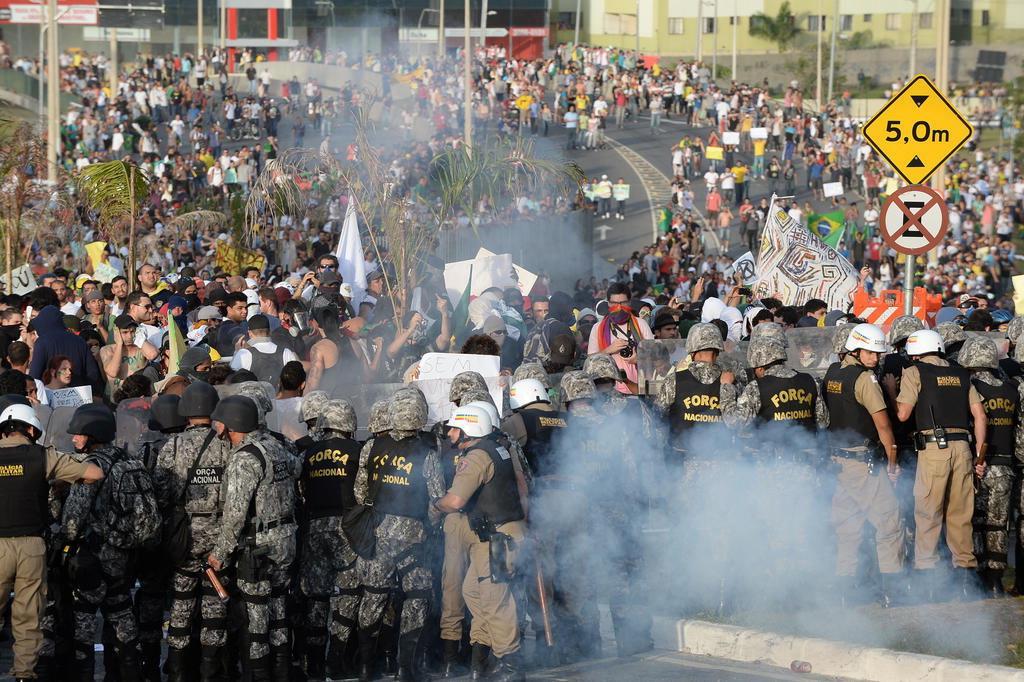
<box><xmin>462</xmin><ymin>521</ymin><xmax>526</xmax><ymax>658</ymax></box>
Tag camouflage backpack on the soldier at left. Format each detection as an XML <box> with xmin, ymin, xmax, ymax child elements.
<box><xmin>99</xmin><ymin>459</ymin><xmax>161</xmax><ymax>549</ymax></box>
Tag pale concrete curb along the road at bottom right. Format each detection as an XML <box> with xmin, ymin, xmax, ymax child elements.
<box><xmin>671</xmin><ymin>619</ymin><xmax>1024</xmax><ymax>682</ymax></box>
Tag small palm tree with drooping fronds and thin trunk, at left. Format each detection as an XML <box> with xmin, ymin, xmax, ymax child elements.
<box><xmin>75</xmin><ymin>161</ymin><xmax>150</xmax><ymax>290</ymax></box>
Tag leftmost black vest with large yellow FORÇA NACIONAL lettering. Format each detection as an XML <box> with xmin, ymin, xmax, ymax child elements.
<box><xmin>302</xmin><ymin>438</ymin><xmax>359</xmax><ymax>518</ymax></box>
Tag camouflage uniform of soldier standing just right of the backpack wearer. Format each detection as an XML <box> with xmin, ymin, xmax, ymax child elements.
<box><xmin>156</xmin><ymin>426</ymin><xmax>230</xmax><ymax>679</ymax></box>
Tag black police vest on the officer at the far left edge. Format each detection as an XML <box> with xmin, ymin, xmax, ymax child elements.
<box><xmin>0</xmin><ymin>444</ymin><xmax>49</xmax><ymax>538</ymax></box>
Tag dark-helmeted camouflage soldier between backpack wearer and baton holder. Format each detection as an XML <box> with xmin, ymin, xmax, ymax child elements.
<box><xmin>155</xmin><ymin>381</ymin><xmax>231</xmax><ymax>682</ymax></box>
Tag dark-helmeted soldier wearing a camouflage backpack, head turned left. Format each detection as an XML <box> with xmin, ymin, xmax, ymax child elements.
<box><xmin>60</xmin><ymin>403</ymin><xmax>161</xmax><ymax>682</ymax></box>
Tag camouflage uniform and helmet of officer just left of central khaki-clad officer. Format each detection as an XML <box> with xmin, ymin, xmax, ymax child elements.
<box><xmin>354</xmin><ymin>387</ymin><xmax>446</xmax><ymax>669</ymax></box>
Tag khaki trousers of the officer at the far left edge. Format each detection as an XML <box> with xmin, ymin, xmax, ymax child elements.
<box><xmin>0</xmin><ymin>537</ymin><xmax>46</xmax><ymax>678</ymax></box>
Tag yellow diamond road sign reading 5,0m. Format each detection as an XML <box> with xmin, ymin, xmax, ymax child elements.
<box><xmin>861</xmin><ymin>76</ymin><xmax>974</xmax><ymax>184</ymax></box>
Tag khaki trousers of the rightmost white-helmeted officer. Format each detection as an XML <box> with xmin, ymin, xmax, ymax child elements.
<box><xmin>913</xmin><ymin>440</ymin><xmax>978</xmax><ymax>569</ymax></box>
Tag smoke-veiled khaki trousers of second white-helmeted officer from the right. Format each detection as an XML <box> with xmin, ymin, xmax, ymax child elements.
<box><xmin>831</xmin><ymin>457</ymin><xmax>903</xmax><ymax>576</ymax></box>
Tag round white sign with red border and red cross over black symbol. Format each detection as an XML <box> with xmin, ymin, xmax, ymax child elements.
<box><xmin>879</xmin><ymin>184</ymin><xmax>949</xmax><ymax>256</ymax></box>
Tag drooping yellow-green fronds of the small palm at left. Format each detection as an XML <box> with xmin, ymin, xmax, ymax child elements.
<box><xmin>75</xmin><ymin>161</ymin><xmax>150</xmax><ymax>229</ymax></box>
